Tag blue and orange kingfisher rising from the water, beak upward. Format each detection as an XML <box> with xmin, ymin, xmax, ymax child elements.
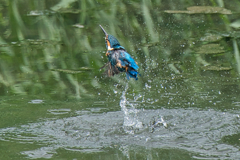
<box><xmin>99</xmin><ymin>25</ymin><xmax>139</xmax><ymax>80</ymax></box>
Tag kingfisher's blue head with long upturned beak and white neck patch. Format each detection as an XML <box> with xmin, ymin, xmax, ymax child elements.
<box><xmin>99</xmin><ymin>25</ymin><xmax>124</xmax><ymax>51</ymax></box>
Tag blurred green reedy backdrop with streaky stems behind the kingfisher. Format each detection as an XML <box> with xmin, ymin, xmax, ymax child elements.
<box><xmin>0</xmin><ymin>0</ymin><xmax>240</xmax><ymax>98</ymax></box>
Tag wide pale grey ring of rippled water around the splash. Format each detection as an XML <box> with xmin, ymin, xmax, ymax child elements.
<box><xmin>0</xmin><ymin>80</ymin><xmax>240</xmax><ymax>159</ymax></box>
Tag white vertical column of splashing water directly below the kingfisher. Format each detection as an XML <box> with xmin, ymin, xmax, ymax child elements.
<box><xmin>120</xmin><ymin>84</ymin><xmax>143</xmax><ymax>134</ymax></box>
